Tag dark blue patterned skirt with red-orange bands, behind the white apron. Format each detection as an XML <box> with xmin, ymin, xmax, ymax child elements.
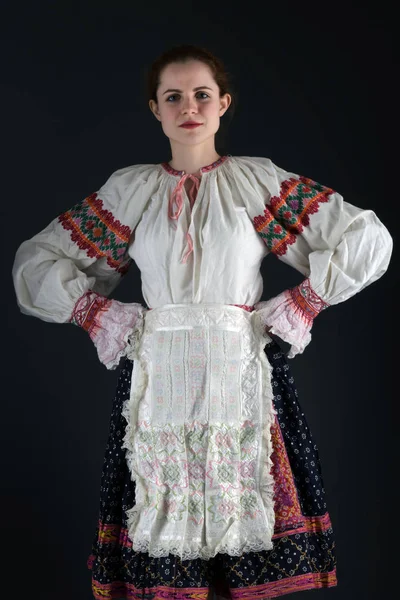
<box><xmin>87</xmin><ymin>340</ymin><xmax>337</xmax><ymax>600</ymax></box>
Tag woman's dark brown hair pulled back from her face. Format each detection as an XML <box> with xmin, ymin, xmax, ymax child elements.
<box><xmin>145</xmin><ymin>44</ymin><xmax>237</xmax><ymax>154</ymax></box>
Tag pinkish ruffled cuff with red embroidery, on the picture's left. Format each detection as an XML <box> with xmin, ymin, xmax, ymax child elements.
<box><xmin>70</xmin><ymin>290</ymin><xmax>147</xmax><ymax>369</ymax></box>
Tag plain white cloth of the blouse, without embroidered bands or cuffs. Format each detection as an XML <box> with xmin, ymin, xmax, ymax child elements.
<box><xmin>13</xmin><ymin>156</ymin><xmax>393</xmax><ymax>322</ymax></box>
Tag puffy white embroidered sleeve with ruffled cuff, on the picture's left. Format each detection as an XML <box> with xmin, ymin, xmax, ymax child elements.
<box><xmin>12</xmin><ymin>165</ymin><xmax>155</xmax><ymax>369</ymax></box>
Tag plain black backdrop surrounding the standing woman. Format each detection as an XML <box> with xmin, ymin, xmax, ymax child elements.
<box><xmin>1</xmin><ymin>1</ymin><xmax>399</xmax><ymax>600</ymax></box>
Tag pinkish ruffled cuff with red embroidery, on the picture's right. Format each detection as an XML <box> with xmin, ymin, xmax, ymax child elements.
<box><xmin>255</xmin><ymin>278</ymin><xmax>329</xmax><ymax>358</ymax></box>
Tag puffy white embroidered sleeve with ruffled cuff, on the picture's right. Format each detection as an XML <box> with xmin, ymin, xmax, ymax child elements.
<box><xmin>236</xmin><ymin>158</ymin><xmax>393</xmax><ymax>358</ymax></box>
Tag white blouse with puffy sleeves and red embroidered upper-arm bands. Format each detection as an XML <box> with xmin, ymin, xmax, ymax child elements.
<box><xmin>13</xmin><ymin>155</ymin><xmax>393</xmax><ymax>360</ymax></box>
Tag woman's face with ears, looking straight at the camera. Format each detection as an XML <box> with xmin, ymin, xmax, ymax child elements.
<box><xmin>149</xmin><ymin>60</ymin><xmax>231</xmax><ymax>145</ymax></box>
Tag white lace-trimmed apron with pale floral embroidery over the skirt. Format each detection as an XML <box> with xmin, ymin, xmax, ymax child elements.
<box><xmin>123</xmin><ymin>304</ymin><xmax>276</xmax><ymax>560</ymax></box>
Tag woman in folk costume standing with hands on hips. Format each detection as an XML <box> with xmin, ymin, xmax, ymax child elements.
<box><xmin>13</xmin><ymin>46</ymin><xmax>392</xmax><ymax>600</ymax></box>
